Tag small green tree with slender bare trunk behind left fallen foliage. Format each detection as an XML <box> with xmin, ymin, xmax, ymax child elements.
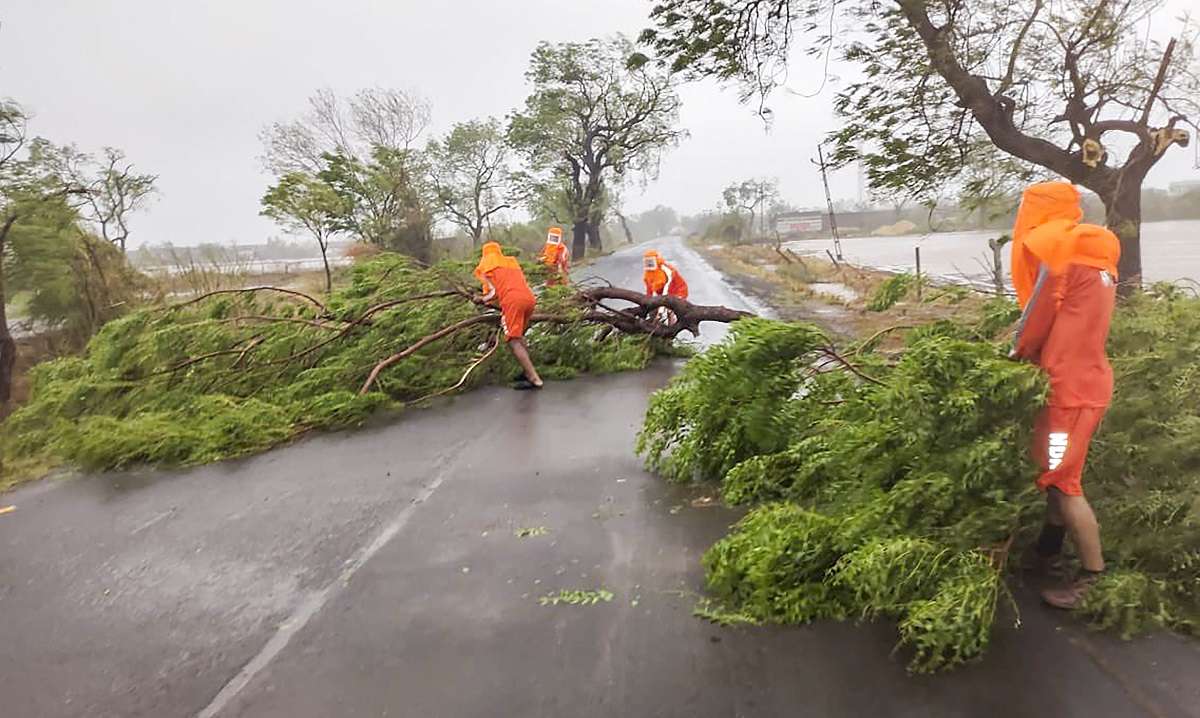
<box><xmin>262</xmin><ymin>172</ymin><xmax>346</xmax><ymax>294</ymax></box>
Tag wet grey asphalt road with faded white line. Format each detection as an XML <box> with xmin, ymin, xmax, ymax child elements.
<box><xmin>0</xmin><ymin>240</ymin><xmax>1200</xmax><ymax>718</ymax></box>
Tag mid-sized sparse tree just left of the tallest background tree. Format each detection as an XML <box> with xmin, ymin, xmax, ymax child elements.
<box><xmin>425</xmin><ymin>118</ymin><xmax>514</xmax><ymax>246</ymax></box>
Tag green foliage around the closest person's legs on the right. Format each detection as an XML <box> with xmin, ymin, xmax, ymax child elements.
<box><xmin>638</xmin><ymin>289</ymin><xmax>1200</xmax><ymax>672</ymax></box>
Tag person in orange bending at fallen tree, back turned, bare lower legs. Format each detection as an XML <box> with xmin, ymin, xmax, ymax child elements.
<box><xmin>475</xmin><ymin>241</ymin><xmax>542</xmax><ymax>389</ymax></box>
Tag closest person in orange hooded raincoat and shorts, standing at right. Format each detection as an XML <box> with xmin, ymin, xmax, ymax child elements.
<box><xmin>1012</xmin><ymin>181</ymin><xmax>1121</xmax><ymax>609</ymax></box>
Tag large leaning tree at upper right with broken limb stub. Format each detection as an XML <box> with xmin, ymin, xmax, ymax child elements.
<box><xmin>638</xmin><ymin>0</ymin><xmax>1200</xmax><ymax>288</ymax></box>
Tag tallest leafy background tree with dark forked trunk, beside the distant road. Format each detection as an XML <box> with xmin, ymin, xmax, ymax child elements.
<box><xmin>509</xmin><ymin>36</ymin><xmax>685</xmax><ymax>258</ymax></box>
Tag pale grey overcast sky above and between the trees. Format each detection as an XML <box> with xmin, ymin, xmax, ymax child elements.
<box><xmin>0</xmin><ymin>0</ymin><xmax>1200</xmax><ymax>250</ymax></box>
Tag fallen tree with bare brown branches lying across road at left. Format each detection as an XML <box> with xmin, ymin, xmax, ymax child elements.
<box><xmin>0</xmin><ymin>255</ymin><xmax>745</xmax><ymax>485</ymax></box>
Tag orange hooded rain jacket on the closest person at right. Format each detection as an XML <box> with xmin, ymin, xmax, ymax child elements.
<box><xmin>1012</xmin><ymin>183</ymin><xmax>1121</xmax><ymax>408</ymax></box>
